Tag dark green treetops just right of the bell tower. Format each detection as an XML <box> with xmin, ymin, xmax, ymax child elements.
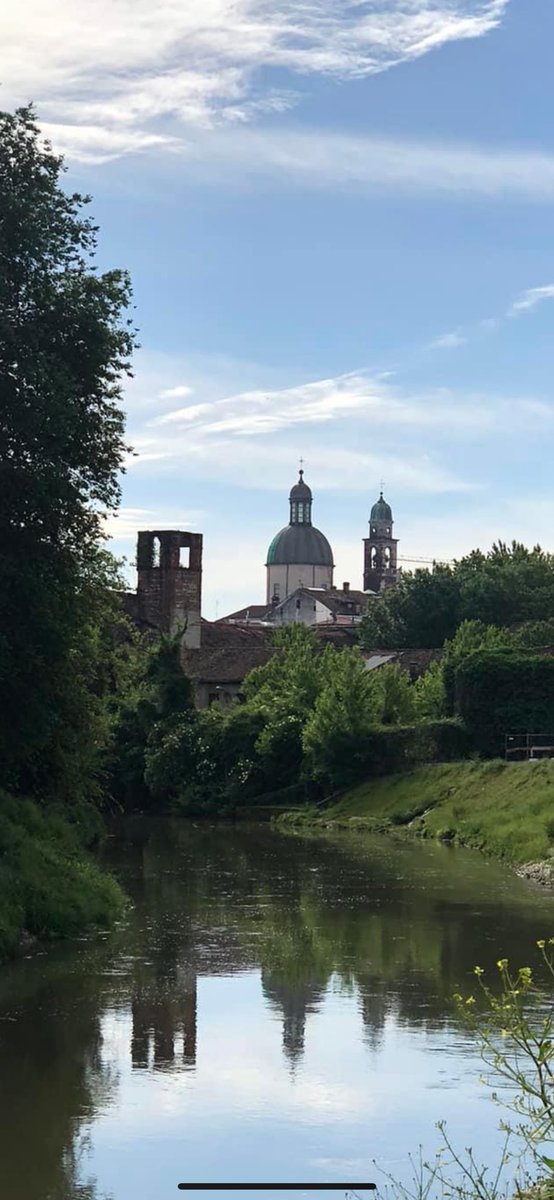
<box><xmin>360</xmin><ymin>541</ymin><xmax>554</xmax><ymax>649</ymax></box>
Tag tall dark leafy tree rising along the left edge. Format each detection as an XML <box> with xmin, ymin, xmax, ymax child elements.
<box><xmin>0</xmin><ymin>108</ymin><xmax>134</xmax><ymax>793</ymax></box>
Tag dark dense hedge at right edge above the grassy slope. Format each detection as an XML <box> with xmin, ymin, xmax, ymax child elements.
<box><xmin>454</xmin><ymin>650</ymin><xmax>554</xmax><ymax>756</ymax></box>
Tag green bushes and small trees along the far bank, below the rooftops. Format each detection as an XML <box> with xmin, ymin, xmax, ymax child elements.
<box><xmin>126</xmin><ymin>626</ymin><xmax>466</xmax><ymax>812</ymax></box>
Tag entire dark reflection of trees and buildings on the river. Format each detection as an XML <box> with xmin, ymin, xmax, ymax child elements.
<box><xmin>0</xmin><ymin>818</ymin><xmax>552</xmax><ymax>1200</ymax></box>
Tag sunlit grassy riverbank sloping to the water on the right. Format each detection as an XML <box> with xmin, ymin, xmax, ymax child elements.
<box><xmin>283</xmin><ymin>761</ymin><xmax>554</xmax><ymax>865</ymax></box>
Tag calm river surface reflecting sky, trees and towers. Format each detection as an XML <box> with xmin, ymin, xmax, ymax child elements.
<box><xmin>0</xmin><ymin>818</ymin><xmax>554</xmax><ymax>1200</ymax></box>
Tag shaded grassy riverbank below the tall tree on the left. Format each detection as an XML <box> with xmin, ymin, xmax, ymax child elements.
<box><xmin>0</xmin><ymin>794</ymin><xmax>125</xmax><ymax>959</ymax></box>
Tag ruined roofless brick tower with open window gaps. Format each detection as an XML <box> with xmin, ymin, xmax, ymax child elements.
<box><xmin>137</xmin><ymin>529</ymin><xmax>203</xmax><ymax>649</ymax></box>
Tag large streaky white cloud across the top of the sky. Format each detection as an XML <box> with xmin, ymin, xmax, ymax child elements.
<box><xmin>0</xmin><ymin>0</ymin><xmax>508</xmax><ymax>161</ymax></box>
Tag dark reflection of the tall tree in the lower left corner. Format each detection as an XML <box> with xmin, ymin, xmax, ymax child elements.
<box><xmin>0</xmin><ymin>948</ymin><xmax>116</xmax><ymax>1200</ymax></box>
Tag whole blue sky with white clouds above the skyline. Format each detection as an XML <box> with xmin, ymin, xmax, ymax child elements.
<box><xmin>0</xmin><ymin>0</ymin><xmax>554</xmax><ymax>617</ymax></box>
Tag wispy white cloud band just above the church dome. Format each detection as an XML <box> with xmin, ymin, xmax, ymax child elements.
<box><xmin>119</xmin><ymin>352</ymin><xmax>517</xmax><ymax>494</ymax></box>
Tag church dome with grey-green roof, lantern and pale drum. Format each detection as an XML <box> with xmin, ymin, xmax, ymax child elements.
<box><xmin>266</xmin><ymin>470</ymin><xmax>335</xmax><ymax>605</ymax></box>
